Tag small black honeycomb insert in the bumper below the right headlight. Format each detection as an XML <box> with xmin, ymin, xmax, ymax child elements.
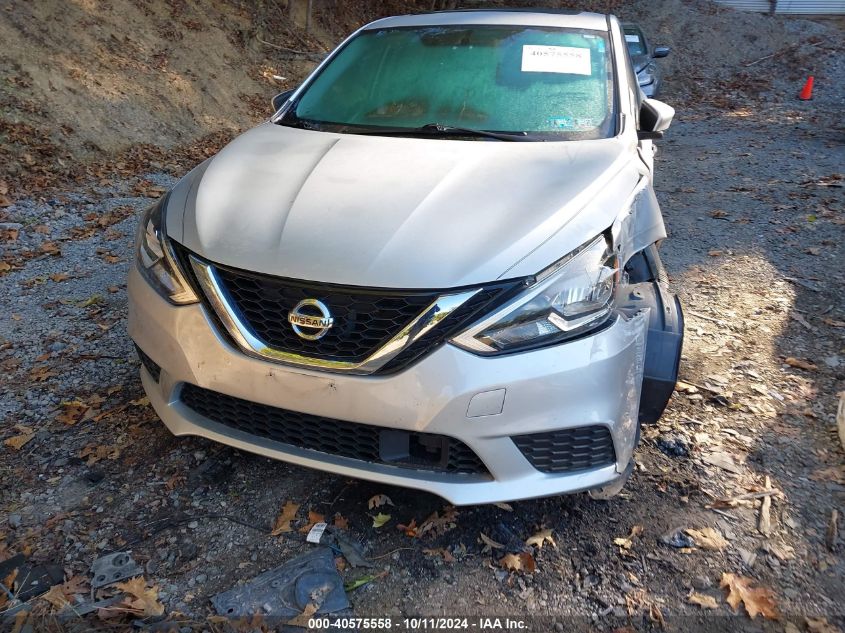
<box><xmin>511</xmin><ymin>426</ymin><xmax>616</xmax><ymax>473</ymax></box>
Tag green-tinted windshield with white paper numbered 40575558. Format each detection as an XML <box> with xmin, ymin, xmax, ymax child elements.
<box><xmin>280</xmin><ymin>25</ymin><xmax>615</xmax><ymax>140</ymax></box>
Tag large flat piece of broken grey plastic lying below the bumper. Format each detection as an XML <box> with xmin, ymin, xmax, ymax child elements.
<box><xmin>211</xmin><ymin>547</ymin><xmax>349</xmax><ymax>618</ymax></box>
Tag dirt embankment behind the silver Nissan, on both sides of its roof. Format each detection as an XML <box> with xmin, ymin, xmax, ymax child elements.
<box><xmin>0</xmin><ymin>0</ymin><xmax>824</xmax><ymax>200</ymax></box>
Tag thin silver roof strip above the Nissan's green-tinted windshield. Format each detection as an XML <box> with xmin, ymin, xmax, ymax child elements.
<box><xmin>364</xmin><ymin>9</ymin><xmax>607</xmax><ymax>31</ymax></box>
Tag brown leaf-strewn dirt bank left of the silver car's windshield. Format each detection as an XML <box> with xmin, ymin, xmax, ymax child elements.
<box><xmin>0</xmin><ymin>0</ymin><xmax>432</xmax><ymax>199</ymax></box>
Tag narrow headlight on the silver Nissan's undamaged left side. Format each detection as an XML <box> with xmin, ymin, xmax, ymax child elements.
<box><xmin>136</xmin><ymin>196</ymin><xmax>199</xmax><ymax>305</ymax></box>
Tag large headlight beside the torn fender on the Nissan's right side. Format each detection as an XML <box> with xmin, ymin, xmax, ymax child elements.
<box><xmin>452</xmin><ymin>236</ymin><xmax>620</xmax><ymax>354</ymax></box>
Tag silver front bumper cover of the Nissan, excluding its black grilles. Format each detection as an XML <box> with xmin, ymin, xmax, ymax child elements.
<box><xmin>129</xmin><ymin>267</ymin><xmax>647</xmax><ymax>505</ymax></box>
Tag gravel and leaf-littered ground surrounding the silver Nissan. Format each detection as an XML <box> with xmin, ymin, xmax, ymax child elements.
<box><xmin>0</xmin><ymin>2</ymin><xmax>845</xmax><ymax>633</ymax></box>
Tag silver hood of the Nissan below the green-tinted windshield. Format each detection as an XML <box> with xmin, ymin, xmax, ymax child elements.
<box><xmin>173</xmin><ymin>123</ymin><xmax>633</xmax><ymax>288</ymax></box>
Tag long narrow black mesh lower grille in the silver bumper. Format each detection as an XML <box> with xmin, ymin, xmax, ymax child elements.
<box><xmin>180</xmin><ymin>383</ymin><xmax>488</xmax><ymax>475</ymax></box>
